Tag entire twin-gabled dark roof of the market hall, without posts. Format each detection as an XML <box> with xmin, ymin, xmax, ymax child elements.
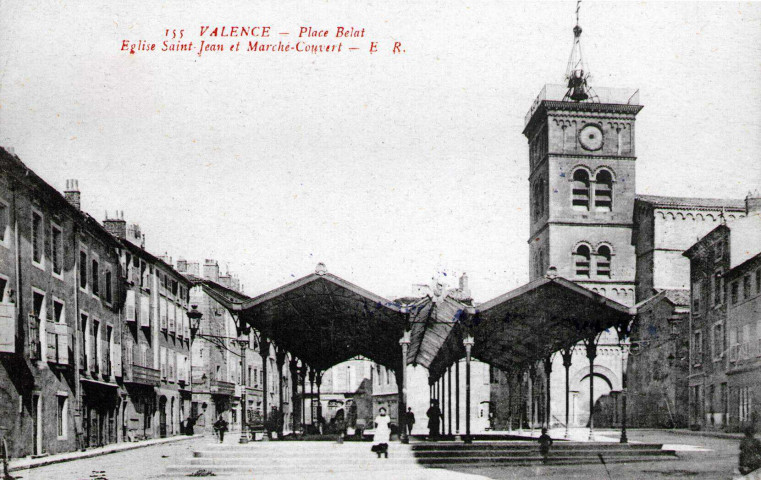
<box><xmin>191</xmin><ymin>268</ymin><xmax>632</xmax><ymax>378</ymax></box>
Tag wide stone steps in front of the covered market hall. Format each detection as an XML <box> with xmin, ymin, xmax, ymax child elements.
<box><xmin>167</xmin><ymin>441</ymin><xmax>676</xmax><ymax>478</ymax></box>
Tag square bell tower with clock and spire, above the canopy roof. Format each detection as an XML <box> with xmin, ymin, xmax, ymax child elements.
<box><xmin>523</xmin><ymin>10</ymin><xmax>642</xmax><ymax>305</ymax></box>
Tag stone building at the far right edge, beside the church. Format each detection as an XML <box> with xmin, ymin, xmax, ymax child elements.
<box><xmin>684</xmin><ymin>199</ymin><xmax>761</xmax><ymax>430</ymax></box>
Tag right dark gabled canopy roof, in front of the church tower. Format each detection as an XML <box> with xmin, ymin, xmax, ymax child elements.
<box><xmin>428</xmin><ymin>277</ymin><xmax>634</xmax><ymax>379</ymax></box>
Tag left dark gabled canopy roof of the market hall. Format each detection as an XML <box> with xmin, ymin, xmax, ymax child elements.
<box><xmin>189</xmin><ymin>273</ymin><xmax>407</xmax><ymax>370</ymax></box>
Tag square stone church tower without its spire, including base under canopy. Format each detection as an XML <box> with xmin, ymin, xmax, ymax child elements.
<box><xmin>521</xmin><ymin>85</ymin><xmax>642</xmax><ymax>426</ymax></box>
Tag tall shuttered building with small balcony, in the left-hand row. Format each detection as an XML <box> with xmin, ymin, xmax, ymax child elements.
<box><xmin>114</xmin><ymin>232</ymin><xmax>191</xmax><ymax>439</ymax></box>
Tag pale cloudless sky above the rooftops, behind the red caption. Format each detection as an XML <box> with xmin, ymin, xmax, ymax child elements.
<box><xmin>0</xmin><ymin>0</ymin><xmax>761</xmax><ymax>301</ymax></box>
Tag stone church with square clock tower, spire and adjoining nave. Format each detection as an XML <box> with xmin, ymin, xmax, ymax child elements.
<box><xmin>491</xmin><ymin>15</ymin><xmax>746</xmax><ymax>430</ymax></box>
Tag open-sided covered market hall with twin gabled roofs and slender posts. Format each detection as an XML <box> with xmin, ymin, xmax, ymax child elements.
<box><xmin>193</xmin><ymin>264</ymin><xmax>634</xmax><ymax>443</ymax></box>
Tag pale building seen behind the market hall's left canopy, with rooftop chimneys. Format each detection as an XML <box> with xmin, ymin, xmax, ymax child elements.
<box><xmin>178</xmin><ymin>259</ymin><xmax>301</xmax><ymax>433</ymax></box>
